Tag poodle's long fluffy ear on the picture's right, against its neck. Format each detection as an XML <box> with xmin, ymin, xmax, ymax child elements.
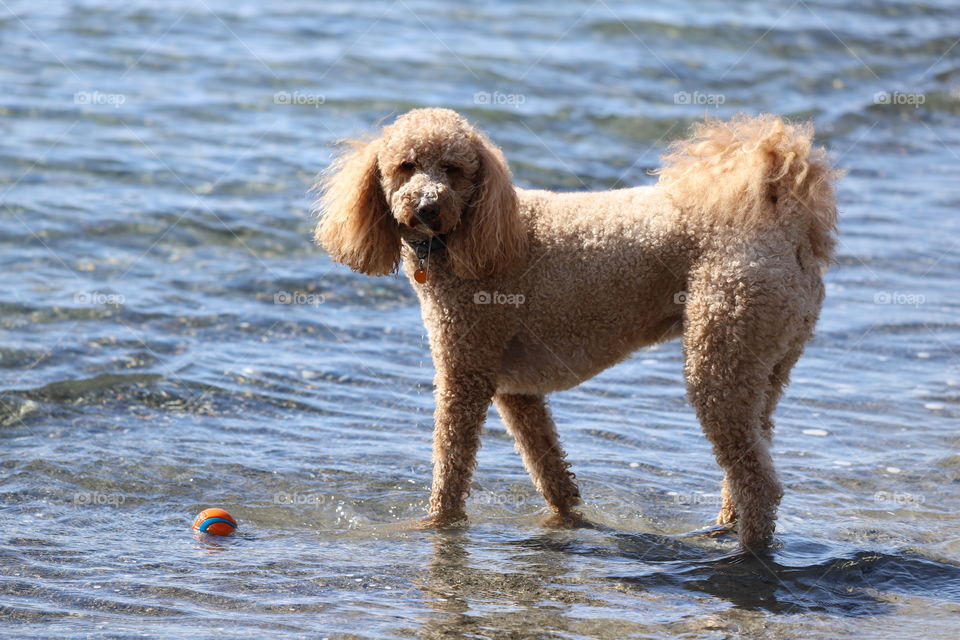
<box><xmin>447</xmin><ymin>132</ymin><xmax>527</xmax><ymax>279</ymax></box>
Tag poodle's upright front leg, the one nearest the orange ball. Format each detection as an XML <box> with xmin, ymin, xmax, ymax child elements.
<box><xmin>425</xmin><ymin>367</ymin><xmax>495</xmax><ymax>526</ymax></box>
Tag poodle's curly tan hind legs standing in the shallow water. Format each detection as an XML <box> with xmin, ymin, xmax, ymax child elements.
<box><xmin>684</xmin><ymin>272</ymin><xmax>803</xmax><ymax>549</ymax></box>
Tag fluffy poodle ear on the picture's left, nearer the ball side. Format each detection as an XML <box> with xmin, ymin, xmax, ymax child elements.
<box><xmin>315</xmin><ymin>140</ymin><xmax>400</xmax><ymax>276</ymax></box>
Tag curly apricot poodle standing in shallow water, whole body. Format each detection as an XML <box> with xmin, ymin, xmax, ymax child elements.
<box><xmin>316</xmin><ymin>108</ymin><xmax>839</xmax><ymax>551</ymax></box>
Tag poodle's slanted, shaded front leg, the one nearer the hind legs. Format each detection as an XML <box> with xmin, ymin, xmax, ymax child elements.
<box><xmin>494</xmin><ymin>394</ymin><xmax>580</xmax><ymax>522</ymax></box>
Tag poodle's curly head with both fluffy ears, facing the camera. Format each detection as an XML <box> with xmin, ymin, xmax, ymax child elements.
<box><xmin>316</xmin><ymin>109</ymin><xmax>526</xmax><ymax>278</ymax></box>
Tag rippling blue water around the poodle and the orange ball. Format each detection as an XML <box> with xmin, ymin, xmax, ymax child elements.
<box><xmin>0</xmin><ymin>0</ymin><xmax>960</xmax><ymax>639</ymax></box>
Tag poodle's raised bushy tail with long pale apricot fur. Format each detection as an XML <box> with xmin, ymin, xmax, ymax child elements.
<box><xmin>657</xmin><ymin>114</ymin><xmax>842</xmax><ymax>263</ymax></box>
